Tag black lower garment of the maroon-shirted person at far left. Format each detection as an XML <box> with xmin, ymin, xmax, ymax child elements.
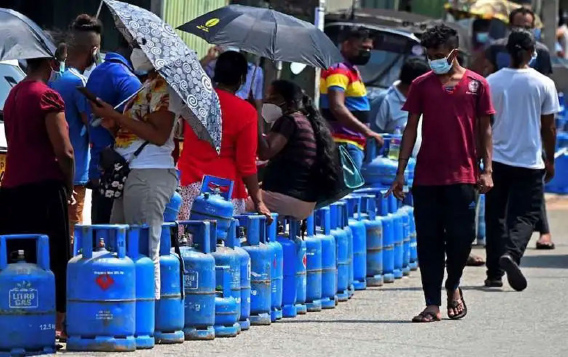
<box><xmin>0</xmin><ymin>181</ymin><xmax>71</xmax><ymax>312</ymax></box>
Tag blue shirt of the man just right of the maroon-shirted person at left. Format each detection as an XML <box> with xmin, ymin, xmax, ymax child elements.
<box><xmin>49</xmin><ymin>68</ymin><xmax>90</xmax><ymax>185</ymax></box>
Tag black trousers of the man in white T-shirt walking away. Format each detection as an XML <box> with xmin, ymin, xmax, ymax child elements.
<box><xmin>485</xmin><ymin>162</ymin><xmax>543</xmax><ymax>279</ymax></box>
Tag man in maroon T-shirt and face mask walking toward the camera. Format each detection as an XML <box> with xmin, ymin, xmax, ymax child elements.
<box><xmin>389</xmin><ymin>25</ymin><xmax>494</xmax><ymax>322</ymax></box>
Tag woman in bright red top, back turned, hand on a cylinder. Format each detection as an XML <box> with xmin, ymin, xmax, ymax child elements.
<box><xmin>178</xmin><ymin>51</ymin><xmax>270</xmax><ymax>220</ymax></box>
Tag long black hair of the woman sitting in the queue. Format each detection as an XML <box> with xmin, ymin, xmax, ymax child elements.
<box><xmin>272</xmin><ymin>80</ymin><xmax>338</xmax><ymax>192</ymax></box>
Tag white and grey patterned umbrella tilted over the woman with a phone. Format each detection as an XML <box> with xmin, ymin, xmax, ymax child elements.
<box><xmin>103</xmin><ymin>0</ymin><xmax>222</xmax><ymax>153</ymax></box>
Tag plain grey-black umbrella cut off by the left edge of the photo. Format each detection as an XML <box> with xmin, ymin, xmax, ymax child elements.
<box><xmin>0</xmin><ymin>8</ymin><xmax>56</xmax><ymax>61</ymax></box>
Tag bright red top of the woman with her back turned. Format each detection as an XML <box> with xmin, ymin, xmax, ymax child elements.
<box><xmin>178</xmin><ymin>89</ymin><xmax>258</xmax><ymax>199</ymax></box>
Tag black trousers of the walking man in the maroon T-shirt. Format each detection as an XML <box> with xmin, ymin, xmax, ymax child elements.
<box><xmin>412</xmin><ymin>184</ymin><xmax>476</xmax><ymax>306</ymax></box>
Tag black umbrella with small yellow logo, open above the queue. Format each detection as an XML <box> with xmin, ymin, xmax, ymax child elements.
<box><xmin>178</xmin><ymin>5</ymin><xmax>343</xmax><ymax>68</ymax></box>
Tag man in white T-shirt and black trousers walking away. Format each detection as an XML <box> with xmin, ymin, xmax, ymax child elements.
<box><xmin>485</xmin><ymin>29</ymin><xmax>560</xmax><ymax>291</ymax></box>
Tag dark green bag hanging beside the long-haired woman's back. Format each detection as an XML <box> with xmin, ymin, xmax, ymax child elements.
<box><xmin>315</xmin><ymin>145</ymin><xmax>365</xmax><ymax>209</ymax></box>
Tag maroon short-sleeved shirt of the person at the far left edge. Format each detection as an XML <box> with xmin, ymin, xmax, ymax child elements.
<box><xmin>2</xmin><ymin>80</ymin><xmax>65</xmax><ymax>187</ymax></box>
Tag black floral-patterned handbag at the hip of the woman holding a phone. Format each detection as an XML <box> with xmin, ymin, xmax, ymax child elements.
<box><xmin>99</xmin><ymin>141</ymin><xmax>149</xmax><ymax>199</ymax></box>
